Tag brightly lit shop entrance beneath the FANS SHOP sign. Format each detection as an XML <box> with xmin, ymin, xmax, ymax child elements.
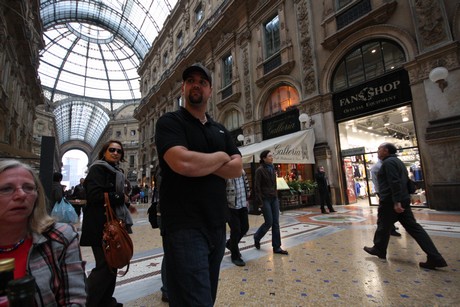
<box><xmin>338</xmin><ymin>105</ymin><xmax>426</xmax><ymax>206</ymax></box>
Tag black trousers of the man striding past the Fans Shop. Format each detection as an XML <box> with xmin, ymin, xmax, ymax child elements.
<box><xmin>374</xmin><ymin>199</ymin><xmax>442</xmax><ymax>260</ymax></box>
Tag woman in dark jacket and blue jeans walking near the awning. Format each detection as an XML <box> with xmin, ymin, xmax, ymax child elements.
<box><xmin>254</xmin><ymin>150</ymin><xmax>288</xmax><ymax>255</ymax></box>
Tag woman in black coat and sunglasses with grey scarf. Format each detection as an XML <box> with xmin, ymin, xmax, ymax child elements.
<box><xmin>80</xmin><ymin>140</ymin><xmax>136</xmax><ymax>307</ymax></box>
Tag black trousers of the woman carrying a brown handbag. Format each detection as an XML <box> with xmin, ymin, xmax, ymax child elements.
<box><xmin>86</xmin><ymin>246</ymin><xmax>117</xmax><ymax>307</ymax></box>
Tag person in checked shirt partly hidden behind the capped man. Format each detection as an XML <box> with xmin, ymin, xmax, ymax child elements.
<box><xmin>225</xmin><ymin>170</ymin><xmax>250</xmax><ymax>266</ymax></box>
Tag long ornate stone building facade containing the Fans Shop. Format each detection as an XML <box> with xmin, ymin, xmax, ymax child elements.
<box><xmin>134</xmin><ymin>0</ymin><xmax>460</xmax><ymax>210</ymax></box>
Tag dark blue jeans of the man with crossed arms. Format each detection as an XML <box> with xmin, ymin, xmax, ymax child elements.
<box><xmin>163</xmin><ymin>225</ymin><xmax>226</xmax><ymax>306</ymax></box>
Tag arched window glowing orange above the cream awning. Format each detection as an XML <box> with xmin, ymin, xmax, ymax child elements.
<box><xmin>263</xmin><ymin>85</ymin><xmax>300</xmax><ymax>117</ymax></box>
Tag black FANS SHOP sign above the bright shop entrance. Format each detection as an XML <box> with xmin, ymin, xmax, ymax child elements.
<box><xmin>332</xmin><ymin>70</ymin><xmax>412</xmax><ymax>121</ymax></box>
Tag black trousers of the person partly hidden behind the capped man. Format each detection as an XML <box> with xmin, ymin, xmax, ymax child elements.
<box><xmin>228</xmin><ymin>207</ymin><xmax>249</xmax><ymax>260</ymax></box>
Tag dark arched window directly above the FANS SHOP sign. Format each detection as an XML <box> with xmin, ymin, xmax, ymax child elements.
<box><xmin>332</xmin><ymin>40</ymin><xmax>406</xmax><ymax>92</ymax></box>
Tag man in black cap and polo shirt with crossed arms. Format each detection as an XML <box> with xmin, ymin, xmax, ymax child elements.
<box><xmin>155</xmin><ymin>64</ymin><xmax>243</xmax><ymax>306</ymax></box>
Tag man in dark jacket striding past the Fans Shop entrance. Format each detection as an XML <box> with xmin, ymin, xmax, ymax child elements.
<box><xmin>364</xmin><ymin>143</ymin><xmax>447</xmax><ymax>269</ymax></box>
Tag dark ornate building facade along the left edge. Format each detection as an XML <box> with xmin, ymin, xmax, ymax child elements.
<box><xmin>0</xmin><ymin>1</ymin><xmax>44</xmax><ymax>164</ymax></box>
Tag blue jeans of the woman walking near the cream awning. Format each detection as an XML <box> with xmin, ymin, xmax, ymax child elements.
<box><xmin>254</xmin><ymin>197</ymin><xmax>281</xmax><ymax>250</ymax></box>
